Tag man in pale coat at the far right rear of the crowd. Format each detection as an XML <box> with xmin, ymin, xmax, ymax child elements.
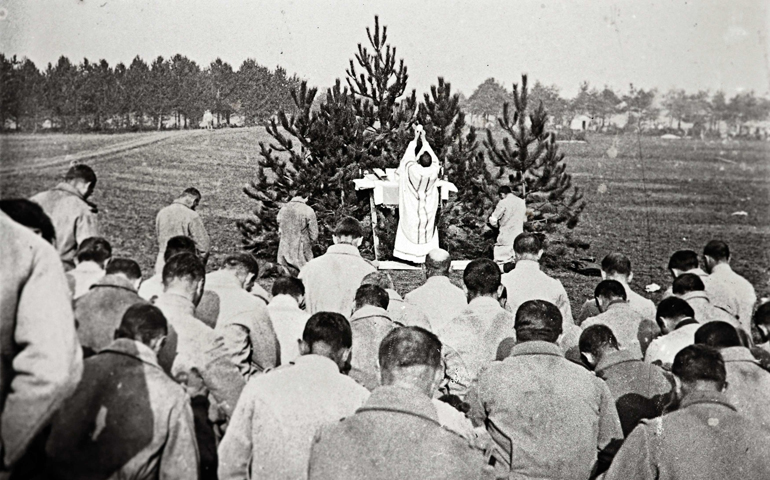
<box><xmin>703</xmin><ymin>240</ymin><xmax>757</xmax><ymax>332</ymax></box>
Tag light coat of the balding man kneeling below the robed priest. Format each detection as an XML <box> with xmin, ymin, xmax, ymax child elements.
<box><xmin>404</xmin><ymin>275</ymin><xmax>468</xmax><ymax>331</ymax></box>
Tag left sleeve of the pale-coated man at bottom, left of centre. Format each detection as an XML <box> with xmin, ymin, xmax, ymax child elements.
<box><xmin>217</xmin><ymin>387</ymin><xmax>254</xmax><ymax>480</ymax></box>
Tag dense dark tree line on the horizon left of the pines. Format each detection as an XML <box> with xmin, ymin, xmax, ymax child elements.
<box><xmin>0</xmin><ymin>53</ymin><xmax>300</xmax><ymax>132</ymax></box>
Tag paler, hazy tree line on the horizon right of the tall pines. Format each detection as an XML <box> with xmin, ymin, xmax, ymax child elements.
<box><xmin>462</xmin><ymin>78</ymin><xmax>770</xmax><ymax>134</ymax></box>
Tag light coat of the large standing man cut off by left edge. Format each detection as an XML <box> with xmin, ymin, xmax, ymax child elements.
<box><xmin>0</xmin><ymin>216</ymin><xmax>83</xmax><ymax>475</ymax></box>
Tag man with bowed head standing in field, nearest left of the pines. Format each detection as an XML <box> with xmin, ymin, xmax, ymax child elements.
<box><xmin>155</xmin><ymin>188</ymin><xmax>211</xmax><ymax>273</ymax></box>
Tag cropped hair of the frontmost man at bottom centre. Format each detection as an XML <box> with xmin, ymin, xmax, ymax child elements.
<box><xmin>379</xmin><ymin>327</ymin><xmax>442</xmax><ymax>371</ymax></box>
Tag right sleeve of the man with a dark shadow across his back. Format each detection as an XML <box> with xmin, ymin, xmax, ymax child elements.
<box><xmin>159</xmin><ymin>395</ymin><xmax>199</xmax><ymax>480</ymax></box>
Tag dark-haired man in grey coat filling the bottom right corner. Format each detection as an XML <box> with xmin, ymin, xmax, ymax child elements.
<box><xmin>605</xmin><ymin>345</ymin><xmax>770</xmax><ymax>480</ymax></box>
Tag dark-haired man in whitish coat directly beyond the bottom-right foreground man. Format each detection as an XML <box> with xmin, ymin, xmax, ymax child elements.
<box><xmin>644</xmin><ymin>297</ymin><xmax>700</xmax><ymax>370</ymax></box>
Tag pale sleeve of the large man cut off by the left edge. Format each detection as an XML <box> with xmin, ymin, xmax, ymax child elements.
<box><xmin>0</xmin><ymin>244</ymin><xmax>83</xmax><ymax>465</ymax></box>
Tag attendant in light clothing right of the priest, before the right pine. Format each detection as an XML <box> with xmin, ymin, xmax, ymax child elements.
<box><xmin>489</xmin><ymin>185</ymin><xmax>527</xmax><ymax>267</ymax></box>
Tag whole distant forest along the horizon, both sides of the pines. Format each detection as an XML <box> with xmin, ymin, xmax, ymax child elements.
<box><xmin>0</xmin><ymin>54</ymin><xmax>770</xmax><ymax>135</ymax></box>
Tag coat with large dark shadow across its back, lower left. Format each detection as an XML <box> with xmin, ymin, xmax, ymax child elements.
<box><xmin>46</xmin><ymin>339</ymin><xmax>198</xmax><ymax>480</ymax></box>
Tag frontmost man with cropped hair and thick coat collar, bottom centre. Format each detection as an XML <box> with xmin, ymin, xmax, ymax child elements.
<box><xmin>309</xmin><ymin>327</ymin><xmax>485</xmax><ymax>480</ymax></box>
